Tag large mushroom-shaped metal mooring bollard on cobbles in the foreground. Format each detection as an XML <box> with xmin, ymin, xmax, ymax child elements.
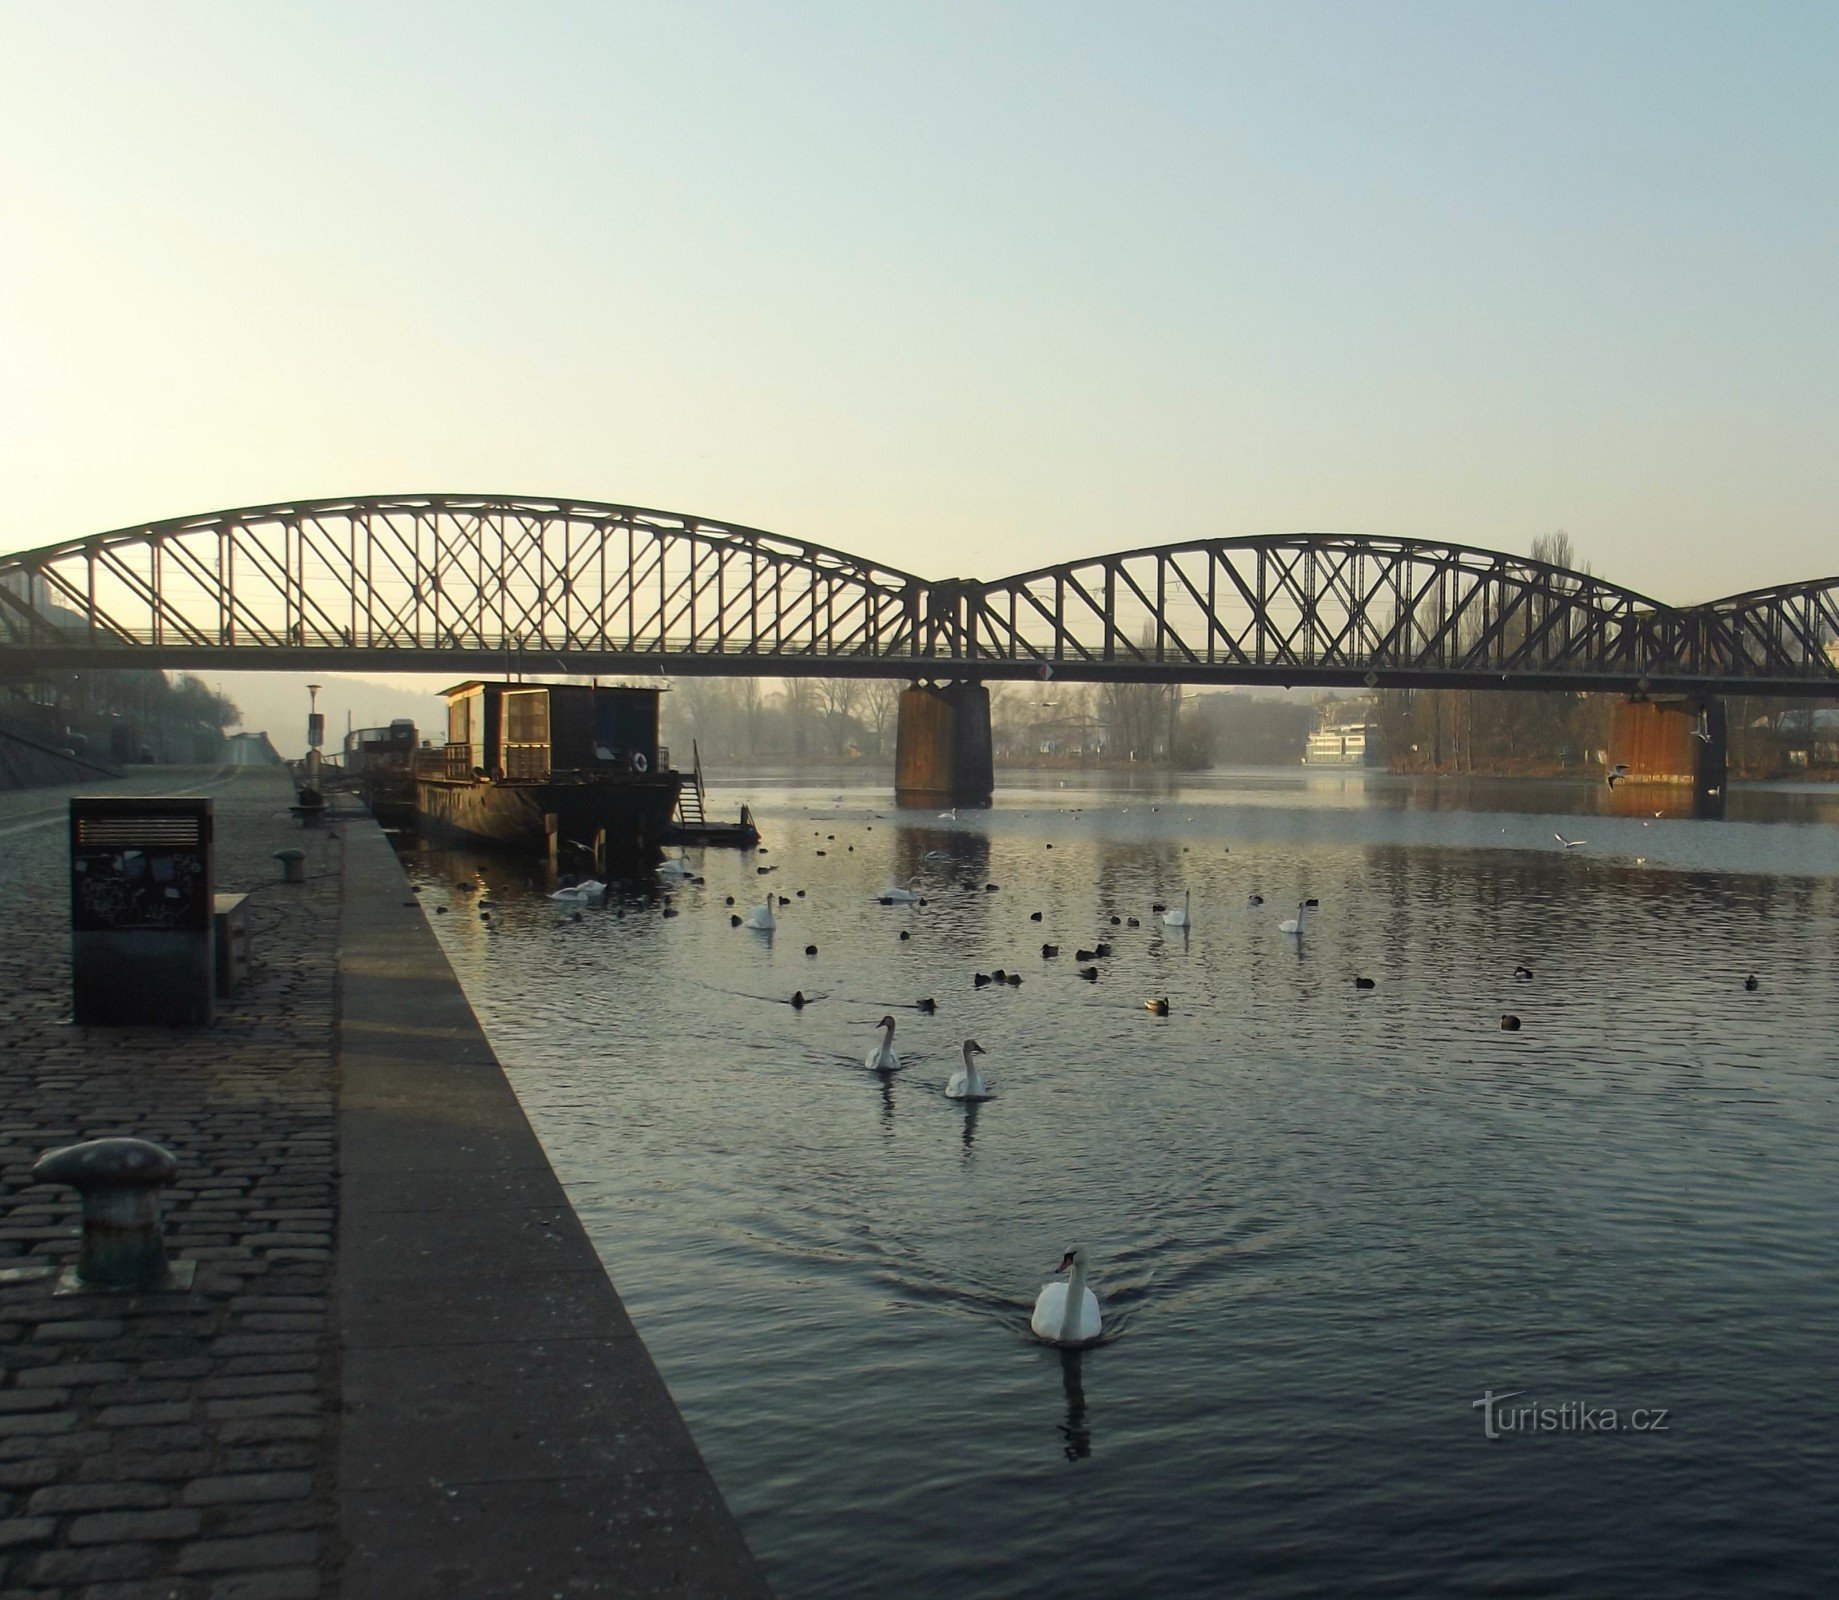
<box><xmin>31</xmin><ymin>1138</ymin><xmax>193</xmax><ymax>1291</ymax></box>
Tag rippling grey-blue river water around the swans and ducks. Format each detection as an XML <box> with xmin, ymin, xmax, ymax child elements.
<box><xmin>410</xmin><ymin>772</ymin><xmax>1839</xmax><ymax>1600</ymax></box>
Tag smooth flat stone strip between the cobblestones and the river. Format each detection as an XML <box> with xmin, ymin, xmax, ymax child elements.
<box><xmin>335</xmin><ymin>817</ymin><xmax>771</xmax><ymax>1600</ymax></box>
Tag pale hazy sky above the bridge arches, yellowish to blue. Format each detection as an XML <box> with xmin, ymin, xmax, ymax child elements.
<box><xmin>0</xmin><ymin>0</ymin><xmax>1839</xmax><ymax>601</ymax></box>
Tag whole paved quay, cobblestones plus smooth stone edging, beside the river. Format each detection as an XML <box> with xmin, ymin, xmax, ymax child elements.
<box><xmin>0</xmin><ymin>769</ymin><xmax>767</xmax><ymax>1600</ymax></box>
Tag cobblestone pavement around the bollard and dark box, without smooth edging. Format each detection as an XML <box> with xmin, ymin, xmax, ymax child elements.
<box><xmin>0</xmin><ymin>769</ymin><xmax>342</xmax><ymax>1600</ymax></box>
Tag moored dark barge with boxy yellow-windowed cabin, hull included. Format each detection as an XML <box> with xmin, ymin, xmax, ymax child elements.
<box><xmin>416</xmin><ymin>679</ymin><xmax>682</xmax><ymax>864</ymax></box>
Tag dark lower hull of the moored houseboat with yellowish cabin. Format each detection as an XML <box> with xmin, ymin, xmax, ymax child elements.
<box><xmin>416</xmin><ymin>772</ymin><xmax>682</xmax><ymax>861</ymax></box>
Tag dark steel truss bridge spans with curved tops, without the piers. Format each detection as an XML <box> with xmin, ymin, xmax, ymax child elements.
<box><xmin>0</xmin><ymin>495</ymin><xmax>1839</xmax><ymax>695</ymax></box>
